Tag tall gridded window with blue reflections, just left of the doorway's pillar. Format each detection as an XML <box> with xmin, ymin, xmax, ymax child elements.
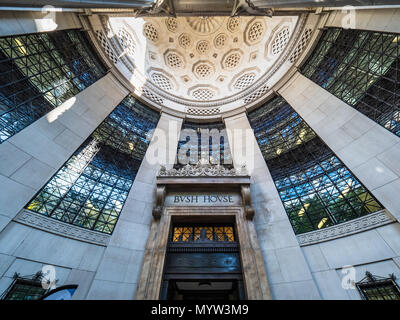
<box><xmin>26</xmin><ymin>96</ymin><xmax>159</xmax><ymax>233</ymax></box>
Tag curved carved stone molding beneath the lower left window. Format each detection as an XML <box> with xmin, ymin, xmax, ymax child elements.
<box><xmin>13</xmin><ymin>209</ymin><xmax>111</xmax><ymax>246</ymax></box>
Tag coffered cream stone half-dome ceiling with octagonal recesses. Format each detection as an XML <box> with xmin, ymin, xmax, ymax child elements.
<box><xmin>92</xmin><ymin>16</ymin><xmax>318</xmax><ymax>116</ymax></box>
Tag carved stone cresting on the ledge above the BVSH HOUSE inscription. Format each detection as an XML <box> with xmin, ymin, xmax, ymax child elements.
<box><xmin>158</xmin><ymin>163</ymin><xmax>249</xmax><ymax>177</ymax></box>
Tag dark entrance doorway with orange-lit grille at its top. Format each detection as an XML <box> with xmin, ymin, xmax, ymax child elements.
<box><xmin>160</xmin><ymin>223</ymin><xmax>246</xmax><ymax>300</ymax></box>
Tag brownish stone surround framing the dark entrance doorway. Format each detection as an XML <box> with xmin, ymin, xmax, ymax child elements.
<box><xmin>135</xmin><ymin>207</ymin><xmax>272</xmax><ymax>300</ymax></box>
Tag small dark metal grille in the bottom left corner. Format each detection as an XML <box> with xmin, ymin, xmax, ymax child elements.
<box><xmin>0</xmin><ymin>272</ymin><xmax>48</xmax><ymax>300</ymax></box>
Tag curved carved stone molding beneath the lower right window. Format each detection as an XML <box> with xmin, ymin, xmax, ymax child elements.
<box><xmin>297</xmin><ymin>210</ymin><xmax>396</xmax><ymax>246</ymax></box>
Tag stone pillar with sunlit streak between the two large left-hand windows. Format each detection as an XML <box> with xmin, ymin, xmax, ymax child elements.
<box><xmin>0</xmin><ymin>74</ymin><xmax>128</xmax><ymax>232</ymax></box>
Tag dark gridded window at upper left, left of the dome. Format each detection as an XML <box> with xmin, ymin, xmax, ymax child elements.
<box><xmin>0</xmin><ymin>30</ymin><xmax>106</xmax><ymax>143</ymax></box>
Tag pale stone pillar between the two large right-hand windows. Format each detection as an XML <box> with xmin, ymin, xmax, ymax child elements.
<box><xmin>278</xmin><ymin>72</ymin><xmax>400</xmax><ymax>221</ymax></box>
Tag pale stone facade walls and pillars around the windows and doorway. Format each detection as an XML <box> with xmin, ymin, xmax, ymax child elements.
<box><xmin>0</xmin><ymin>9</ymin><xmax>400</xmax><ymax>299</ymax></box>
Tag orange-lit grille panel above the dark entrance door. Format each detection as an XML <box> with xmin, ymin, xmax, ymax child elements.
<box><xmin>171</xmin><ymin>225</ymin><xmax>236</xmax><ymax>243</ymax></box>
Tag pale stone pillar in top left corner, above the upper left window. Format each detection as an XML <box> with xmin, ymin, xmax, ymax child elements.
<box><xmin>0</xmin><ymin>11</ymin><xmax>82</xmax><ymax>37</ymax></box>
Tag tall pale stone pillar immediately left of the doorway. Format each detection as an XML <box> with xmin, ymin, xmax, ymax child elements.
<box><xmin>87</xmin><ymin>113</ymin><xmax>183</xmax><ymax>300</ymax></box>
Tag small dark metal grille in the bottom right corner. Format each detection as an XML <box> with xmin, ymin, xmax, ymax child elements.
<box><xmin>356</xmin><ymin>271</ymin><xmax>400</xmax><ymax>300</ymax></box>
